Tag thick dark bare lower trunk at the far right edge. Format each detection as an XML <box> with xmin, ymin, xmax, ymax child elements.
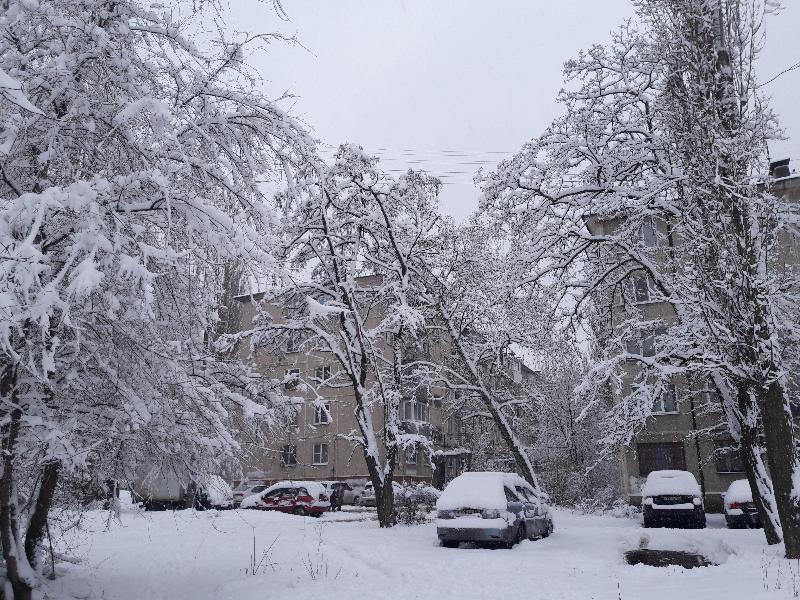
<box><xmin>758</xmin><ymin>381</ymin><xmax>800</xmax><ymax>559</ymax></box>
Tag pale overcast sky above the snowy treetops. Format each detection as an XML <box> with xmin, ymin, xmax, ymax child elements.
<box><xmin>223</xmin><ymin>0</ymin><xmax>800</xmax><ymax>219</ymax></box>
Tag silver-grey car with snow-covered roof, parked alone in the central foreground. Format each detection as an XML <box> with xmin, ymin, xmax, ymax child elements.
<box><xmin>436</xmin><ymin>472</ymin><xmax>554</xmax><ymax>548</ymax></box>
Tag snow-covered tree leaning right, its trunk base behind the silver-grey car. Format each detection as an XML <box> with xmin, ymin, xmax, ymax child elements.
<box><xmin>420</xmin><ymin>223</ymin><xmax>549</xmax><ymax>486</ymax></box>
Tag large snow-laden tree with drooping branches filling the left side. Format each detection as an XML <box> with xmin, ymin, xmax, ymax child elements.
<box><xmin>0</xmin><ymin>0</ymin><xmax>314</xmax><ymax>599</ymax></box>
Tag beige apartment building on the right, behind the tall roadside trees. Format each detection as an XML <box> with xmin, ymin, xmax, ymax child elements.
<box><xmin>588</xmin><ymin>161</ymin><xmax>800</xmax><ymax>511</ymax></box>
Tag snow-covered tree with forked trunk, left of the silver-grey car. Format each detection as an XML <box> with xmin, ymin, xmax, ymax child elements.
<box><xmin>233</xmin><ymin>145</ymin><xmax>440</xmax><ymax>527</ymax></box>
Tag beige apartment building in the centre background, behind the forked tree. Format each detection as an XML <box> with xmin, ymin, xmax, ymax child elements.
<box><xmin>236</xmin><ymin>278</ymin><xmax>476</xmax><ymax>485</ymax></box>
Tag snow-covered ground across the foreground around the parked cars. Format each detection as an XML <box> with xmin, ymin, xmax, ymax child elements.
<box><xmin>47</xmin><ymin>509</ymin><xmax>800</xmax><ymax>600</ymax></box>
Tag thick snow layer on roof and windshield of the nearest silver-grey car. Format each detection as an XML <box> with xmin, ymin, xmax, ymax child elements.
<box><xmin>436</xmin><ymin>471</ymin><xmax>534</xmax><ymax>510</ymax></box>
